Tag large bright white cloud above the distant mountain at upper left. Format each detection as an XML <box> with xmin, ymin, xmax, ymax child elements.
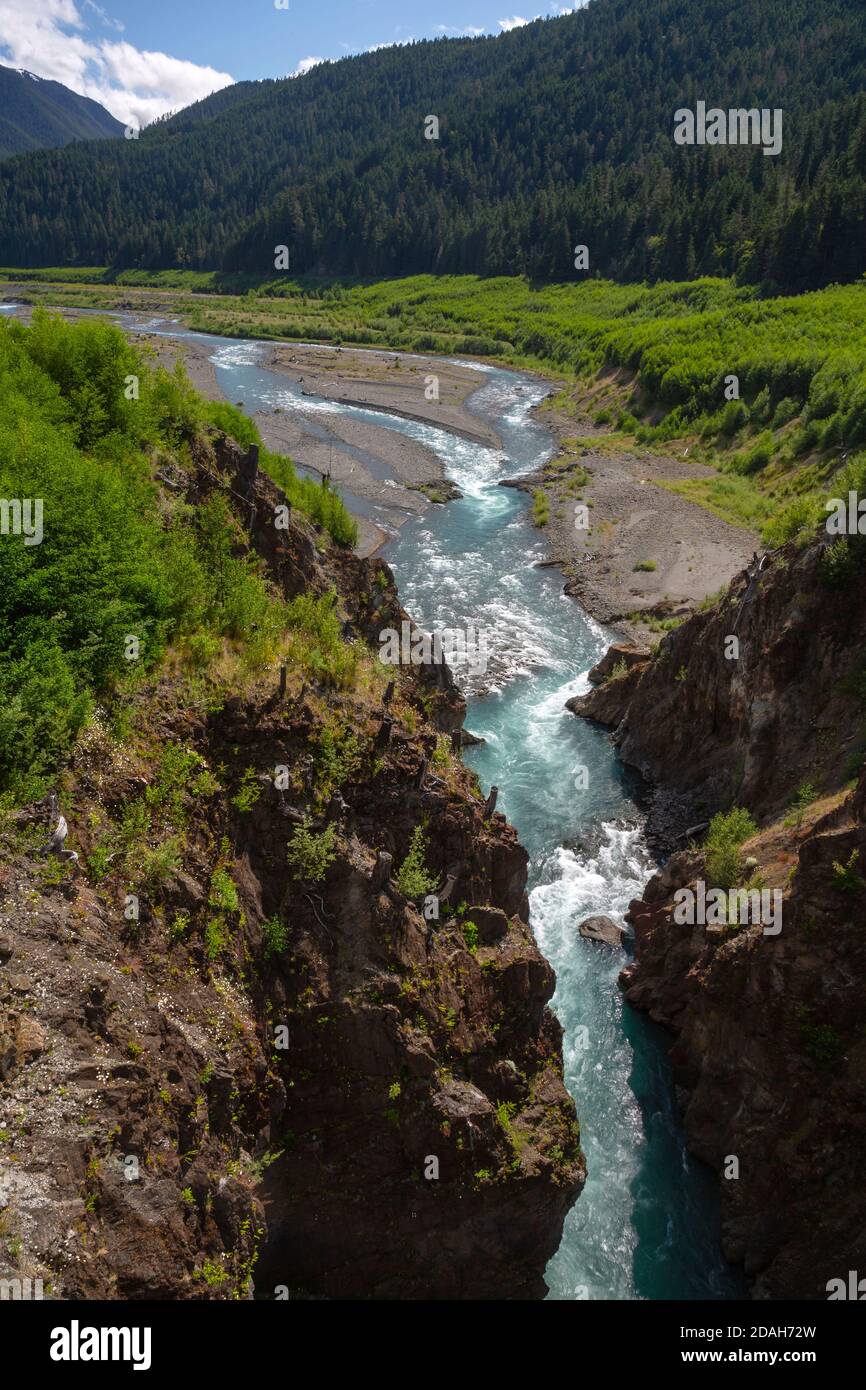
<box><xmin>0</xmin><ymin>0</ymin><xmax>235</xmax><ymax>125</ymax></box>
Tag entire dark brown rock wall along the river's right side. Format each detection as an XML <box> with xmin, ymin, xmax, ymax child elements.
<box><xmin>573</xmin><ymin>545</ymin><xmax>866</xmax><ymax>1298</ymax></box>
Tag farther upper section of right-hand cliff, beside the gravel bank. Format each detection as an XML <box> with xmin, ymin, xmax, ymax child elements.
<box><xmin>569</xmin><ymin>543</ymin><xmax>866</xmax><ymax>833</ymax></box>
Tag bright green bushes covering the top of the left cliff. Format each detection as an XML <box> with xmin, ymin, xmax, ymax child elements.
<box><xmin>0</xmin><ymin>310</ymin><xmax>354</xmax><ymax>798</ymax></box>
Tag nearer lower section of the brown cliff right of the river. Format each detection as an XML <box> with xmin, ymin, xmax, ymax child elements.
<box><xmin>620</xmin><ymin>774</ymin><xmax>866</xmax><ymax>1298</ymax></box>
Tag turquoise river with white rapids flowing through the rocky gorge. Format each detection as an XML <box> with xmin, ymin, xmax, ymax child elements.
<box><xmin>0</xmin><ymin>306</ymin><xmax>745</xmax><ymax>1300</ymax></box>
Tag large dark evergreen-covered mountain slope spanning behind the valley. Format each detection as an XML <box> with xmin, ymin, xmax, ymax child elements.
<box><xmin>0</xmin><ymin>0</ymin><xmax>866</xmax><ymax>291</ymax></box>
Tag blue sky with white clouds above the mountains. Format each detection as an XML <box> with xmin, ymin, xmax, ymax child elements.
<box><xmin>0</xmin><ymin>0</ymin><xmax>589</xmax><ymax>126</ymax></box>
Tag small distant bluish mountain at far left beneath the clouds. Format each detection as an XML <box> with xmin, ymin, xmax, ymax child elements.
<box><xmin>0</xmin><ymin>67</ymin><xmax>124</xmax><ymax>158</ymax></box>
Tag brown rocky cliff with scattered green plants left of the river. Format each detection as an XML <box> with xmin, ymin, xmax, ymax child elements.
<box><xmin>0</xmin><ymin>442</ymin><xmax>584</xmax><ymax>1298</ymax></box>
